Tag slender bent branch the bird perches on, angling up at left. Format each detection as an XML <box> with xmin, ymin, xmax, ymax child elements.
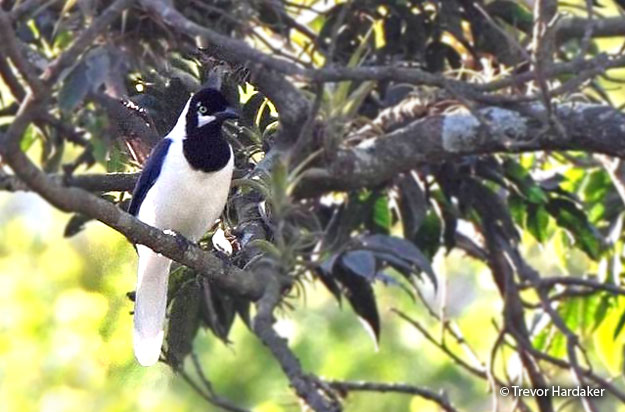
<box><xmin>0</xmin><ymin>0</ymin><xmax>264</xmax><ymax>306</ymax></box>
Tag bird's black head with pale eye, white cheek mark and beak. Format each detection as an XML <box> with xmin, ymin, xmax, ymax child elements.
<box><xmin>187</xmin><ymin>88</ymin><xmax>239</xmax><ymax>135</ymax></box>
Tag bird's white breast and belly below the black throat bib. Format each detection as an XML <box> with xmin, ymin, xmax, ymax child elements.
<box><xmin>137</xmin><ymin>138</ymin><xmax>234</xmax><ymax>240</ymax></box>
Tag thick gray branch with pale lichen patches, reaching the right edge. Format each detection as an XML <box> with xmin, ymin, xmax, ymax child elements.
<box><xmin>296</xmin><ymin>103</ymin><xmax>625</xmax><ymax>196</ymax></box>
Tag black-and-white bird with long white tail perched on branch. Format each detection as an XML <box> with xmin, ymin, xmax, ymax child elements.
<box><xmin>128</xmin><ymin>88</ymin><xmax>238</xmax><ymax>366</ymax></box>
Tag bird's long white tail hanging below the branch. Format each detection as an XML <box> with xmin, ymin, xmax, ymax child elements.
<box><xmin>133</xmin><ymin>245</ymin><xmax>171</xmax><ymax>366</ymax></box>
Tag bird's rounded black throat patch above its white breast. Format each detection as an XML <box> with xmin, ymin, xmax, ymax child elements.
<box><xmin>182</xmin><ymin>122</ymin><xmax>232</xmax><ymax>173</ymax></box>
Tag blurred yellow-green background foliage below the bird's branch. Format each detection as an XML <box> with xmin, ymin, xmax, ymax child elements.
<box><xmin>0</xmin><ymin>194</ymin><xmax>496</xmax><ymax>412</ymax></box>
